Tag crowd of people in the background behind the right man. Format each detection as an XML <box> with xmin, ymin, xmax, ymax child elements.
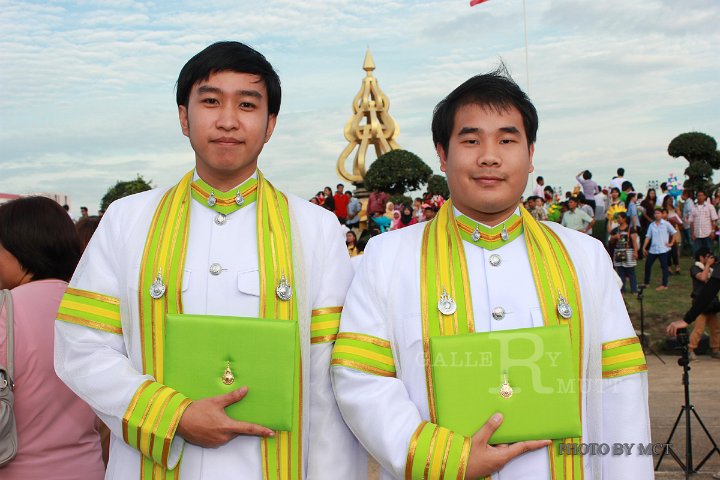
<box><xmin>310</xmin><ymin>168</ymin><xmax>720</xmax><ymax>308</ymax></box>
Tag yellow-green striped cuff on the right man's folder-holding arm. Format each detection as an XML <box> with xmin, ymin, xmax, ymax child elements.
<box><xmin>405</xmin><ymin>422</ymin><xmax>470</xmax><ymax>480</ymax></box>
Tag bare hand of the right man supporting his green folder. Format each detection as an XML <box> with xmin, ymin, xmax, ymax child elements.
<box><xmin>465</xmin><ymin>413</ymin><xmax>551</xmax><ymax>480</ymax></box>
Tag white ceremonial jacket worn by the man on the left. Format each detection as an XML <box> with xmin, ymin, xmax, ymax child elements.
<box><xmin>55</xmin><ymin>182</ymin><xmax>367</xmax><ymax>480</ymax></box>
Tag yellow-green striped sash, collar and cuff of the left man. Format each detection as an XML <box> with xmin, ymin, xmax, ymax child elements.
<box><xmin>123</xmin><ymin>171</ymin><xmax>302</xmax><ymax>480</ymax></box>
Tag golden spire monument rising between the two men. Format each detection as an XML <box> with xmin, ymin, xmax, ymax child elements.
<box><xmin>337</xmin><ymin>48</ymin><xmax>400</xmax><ymax>186</ymax></box>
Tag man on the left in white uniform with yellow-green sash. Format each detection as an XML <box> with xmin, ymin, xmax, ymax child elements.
<box><xmin>55</xmin><ymin>42</ymin><xmax>367</xmax><ymax>480</ymax></box>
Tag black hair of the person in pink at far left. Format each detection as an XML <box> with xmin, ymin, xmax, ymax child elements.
<box><xmin>0</xmin><ymin>197</ymin><xmax>81</xmax><ymax>281</ymax></box>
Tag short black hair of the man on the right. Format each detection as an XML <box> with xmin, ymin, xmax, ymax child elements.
<box><xmin>432</xmin><ymin>64</ymin><xmax>538</xmax><ymax>153</ymax></box>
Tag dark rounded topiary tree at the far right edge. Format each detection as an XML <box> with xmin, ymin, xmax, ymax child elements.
<box><xmin>668</xmin><ymin>132</ymin><xmax>720</xmax><ymax>195</ymax></box>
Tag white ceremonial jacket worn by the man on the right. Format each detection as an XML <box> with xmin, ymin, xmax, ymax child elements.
<box><xmin>331</xmin><ymin>218</ymin><xmax>653</xmax><ymax>480</ymax></box>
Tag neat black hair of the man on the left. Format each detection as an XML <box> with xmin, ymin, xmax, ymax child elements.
<box><xmin>176</xmin><ymin>42</ymin><xmax>282</xmax><ymax>115</ymax></box>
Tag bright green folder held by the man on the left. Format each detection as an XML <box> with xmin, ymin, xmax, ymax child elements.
<box><xmin>164</xmin><ymin>314</ymin><xmax>298</xmax><ymax>431</ymax></box>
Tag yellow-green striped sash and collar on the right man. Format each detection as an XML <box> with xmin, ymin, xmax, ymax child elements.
<box><xmin>416</xmin><ymin>201</ymin><xmax>583</xmax><ymax>480</ymax></box>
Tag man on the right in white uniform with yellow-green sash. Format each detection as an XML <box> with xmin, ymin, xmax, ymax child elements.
<box><xmin>332</xmin><ymin>66</ymin><xmax>653</xmax><ymax>480</ymax></box>
